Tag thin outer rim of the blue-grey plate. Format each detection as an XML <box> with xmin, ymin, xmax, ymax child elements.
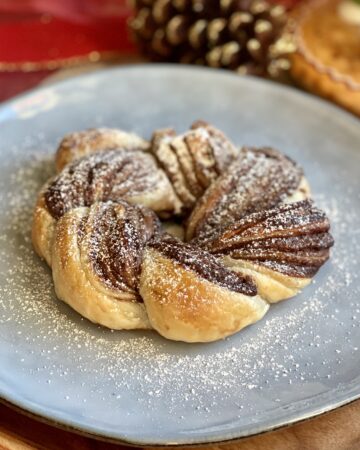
<box><xmin>0</xmin><ymin>63</ymin><xmax>360</xmax><ymax>447</ymax></box>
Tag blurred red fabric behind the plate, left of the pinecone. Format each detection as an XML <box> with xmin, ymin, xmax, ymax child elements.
<box><xmin>0</xmin><ymin>0</ymin><xmax>134</xmax><ymax>69</ymax></box>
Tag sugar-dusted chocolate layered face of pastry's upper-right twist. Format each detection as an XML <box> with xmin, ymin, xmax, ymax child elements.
<box><xmin>187</xmin><ymin>148</ymin><xmax>303</xmax><ymax>240</ymax></box>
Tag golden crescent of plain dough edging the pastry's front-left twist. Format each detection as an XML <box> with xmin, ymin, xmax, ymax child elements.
<box><xmin>52</xmin><ymin>208</ymin><xmax>151</xmax><ymax>329</ymax></box>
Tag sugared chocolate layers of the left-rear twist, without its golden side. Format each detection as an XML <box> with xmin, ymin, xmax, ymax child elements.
<box><xmin>44</xmin><ymin>149</ymin><xmax>172</xmax><ymax>219</ymax></box>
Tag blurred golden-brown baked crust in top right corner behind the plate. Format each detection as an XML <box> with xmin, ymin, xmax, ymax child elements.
<box><xmin>291</xmin><ymin>0</ymin><xmax>360</xmax><ymax>115</ymax></box>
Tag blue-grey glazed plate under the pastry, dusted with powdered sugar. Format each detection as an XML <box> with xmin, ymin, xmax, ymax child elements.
<box><xmin>0</xmin><ymin>65</ymin><xmax>360</xmax><ymax>445</ymax></box>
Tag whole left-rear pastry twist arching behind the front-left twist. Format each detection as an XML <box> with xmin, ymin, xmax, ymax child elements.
<box><xmin>32</xmin><ymin>148</ymin><xmax>176</xmax><ymax>265</ymax></box>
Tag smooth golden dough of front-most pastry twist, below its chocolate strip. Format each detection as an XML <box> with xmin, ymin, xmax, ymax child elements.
<box><xmin>140</xmin><ymin>249</ymin><xmax>269</xmax><ymax>342</ymax></box>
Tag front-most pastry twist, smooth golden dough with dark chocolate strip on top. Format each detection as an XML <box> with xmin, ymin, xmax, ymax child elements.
<box><xmin>140</xmin><ymin>235</ymin><xmax>269</xmax><ymax>342</ymax></box>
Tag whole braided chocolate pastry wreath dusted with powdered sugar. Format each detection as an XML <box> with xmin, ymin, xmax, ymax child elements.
<box><xmin>32</xmin><ymin>122</ymin><xmax>333</xmax><ymax>342</ymax></box>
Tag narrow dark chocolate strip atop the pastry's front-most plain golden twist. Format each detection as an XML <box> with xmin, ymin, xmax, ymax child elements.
<box><xmin>148</xmin><ymin>234</ymin><xmax>257</xmax><ymax>296</ymax></box>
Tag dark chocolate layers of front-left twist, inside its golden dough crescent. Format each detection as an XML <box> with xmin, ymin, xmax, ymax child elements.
<box><xmin>78</xmin><ymin>201</ymin><xmax>160</xmax><ymax>301</ymax></box>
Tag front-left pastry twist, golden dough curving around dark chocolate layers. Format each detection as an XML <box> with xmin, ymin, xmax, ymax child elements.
<box><xmin>52</xmin><ymin>201</ymin><xmax>160</xmax><ymax>329</ymax></box>
